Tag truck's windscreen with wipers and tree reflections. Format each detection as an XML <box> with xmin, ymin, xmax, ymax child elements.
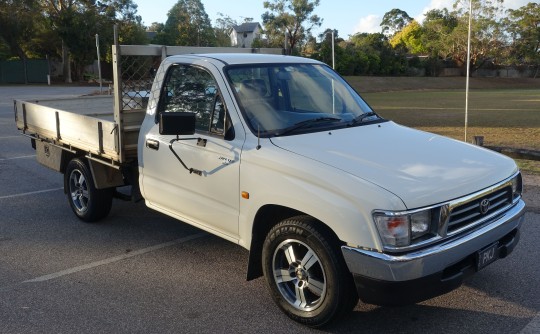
<box><xmin>227</xmin><ymin>64</ymin><xmax>380</xmax><ymax>137</ymax></box>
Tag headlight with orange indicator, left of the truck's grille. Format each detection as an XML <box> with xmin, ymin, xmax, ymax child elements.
<box><xmin>373</xmin><ymin>210</ymin><xmax>432</xmax><ymax>247</ymax></box>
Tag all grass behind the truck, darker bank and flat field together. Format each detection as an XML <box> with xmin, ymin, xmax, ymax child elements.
<box><xmin>346</xmin><ymin>77</ymin><xmax>540</xmax><ymax>173</ymax></box>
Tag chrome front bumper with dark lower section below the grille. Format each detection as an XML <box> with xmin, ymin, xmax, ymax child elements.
<box><xmin>342</xmin><ymin>200</ymin><xmax>525</xmax><ymax>305</ymax></box>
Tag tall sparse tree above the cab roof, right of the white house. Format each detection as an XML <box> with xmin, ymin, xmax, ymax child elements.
<box><xmin>262</xmin><ymin>0</ymin><xmax>322</xmax><ymax>53</ymax></box>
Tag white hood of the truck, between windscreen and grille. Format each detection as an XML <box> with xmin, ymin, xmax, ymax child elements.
<box><xmin>271</xmin><ymin>122</ymin><xmax>517</xmax><ymax>209</ymax></box>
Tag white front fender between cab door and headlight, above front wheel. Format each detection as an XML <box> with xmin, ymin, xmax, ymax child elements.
<box><xmin>239</xmin><ymin>144</ymin><xmax>406</xmax><ymax>250</ymax></box>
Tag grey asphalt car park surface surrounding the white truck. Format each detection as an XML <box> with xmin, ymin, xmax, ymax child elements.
<box><xmin>0</xmin><ymin>86</ymin><xmax>540</xmax><ymax>333</ymax></box>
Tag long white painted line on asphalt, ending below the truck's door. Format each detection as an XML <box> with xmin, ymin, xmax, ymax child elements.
<box><xmin>22</xmin><ymin>233</ymin><xmax>208</xmax><ymax>283</ymax></box>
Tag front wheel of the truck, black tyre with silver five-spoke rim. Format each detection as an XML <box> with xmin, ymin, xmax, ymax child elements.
<box><xmin>262</xmin><ymin>216</ymin><xmax>358</xmax><ymax>327</ymax></box>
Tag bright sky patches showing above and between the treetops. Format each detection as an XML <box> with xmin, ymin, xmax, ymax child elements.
<box><xmin>133</xmin><ymin>0</ymin><xmax>537</xmax><ymax>39</ymax></box>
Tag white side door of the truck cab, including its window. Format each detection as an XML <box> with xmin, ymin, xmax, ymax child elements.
<box><xmin>141</xmin><ymin>64</ymin><xmax>244</xmax><ymax>240</ymax></box>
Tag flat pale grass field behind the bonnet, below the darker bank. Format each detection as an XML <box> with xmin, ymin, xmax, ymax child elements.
<box><xmin>363</xmin><ymin>89</ymin><xmax>540</xmax><ymax>150</ymax></box>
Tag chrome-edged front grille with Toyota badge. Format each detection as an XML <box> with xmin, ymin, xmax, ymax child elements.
<box><xmin>447</xmin><ymin>187</ymin><xmax>512</xmax><ymax>234</ymax></box>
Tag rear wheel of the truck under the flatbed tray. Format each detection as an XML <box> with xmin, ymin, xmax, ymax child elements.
<box><xmin>64</xmin><ymin>158</ymin><xmax>114</xmax><ymax>223</ymax></box>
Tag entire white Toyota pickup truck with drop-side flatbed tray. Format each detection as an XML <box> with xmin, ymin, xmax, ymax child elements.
<box><xmin>15</xmin><ymin>46</ymin><xmax>525</xmax><ymax>327</ymax></box>
